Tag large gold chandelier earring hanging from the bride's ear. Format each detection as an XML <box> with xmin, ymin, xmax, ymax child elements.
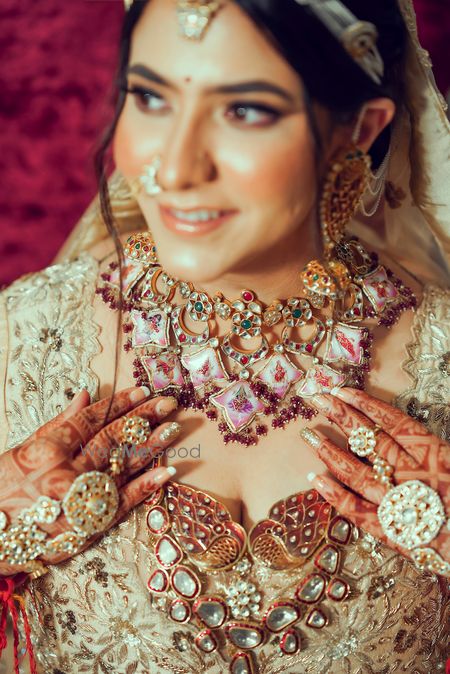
<box><xmin>319</xmin><ymin>142</ymin><xmax>371</xmax><ymax>258</ymax></box>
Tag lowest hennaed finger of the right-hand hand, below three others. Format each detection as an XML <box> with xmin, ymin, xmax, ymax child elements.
<box><xmin>308</xmin><ymin>473</ymin><xmax>405</xmax><ymax>555</ymax></box>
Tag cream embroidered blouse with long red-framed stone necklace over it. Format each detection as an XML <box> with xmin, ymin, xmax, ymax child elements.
<box><xmin>0</xmin><ymin>253</ymin><xmax>450</xmax><ymax>674</ymax></box>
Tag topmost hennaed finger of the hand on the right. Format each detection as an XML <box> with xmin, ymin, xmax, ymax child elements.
<box><xmin>334</xmin><ymin>387</ymin><xmax>432</xmax><ymax>464</ymax></box>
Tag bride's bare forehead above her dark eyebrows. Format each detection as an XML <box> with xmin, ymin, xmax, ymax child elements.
<box><xmin>130</xmin><ymin>0</ymin><xmax>300</xmax><ymax>93</ymax></box>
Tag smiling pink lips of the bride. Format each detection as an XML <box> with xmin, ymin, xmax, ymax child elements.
<box><xmin>159</xmin><ymin>205</ymin><xmax>237</xmax><ymax>235</ymax></box>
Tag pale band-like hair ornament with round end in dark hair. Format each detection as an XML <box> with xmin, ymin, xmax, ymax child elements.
<box><xmin>295</xmin><ymin>0</ymin><xmax>384</xmax><ymax>84</ymax></box>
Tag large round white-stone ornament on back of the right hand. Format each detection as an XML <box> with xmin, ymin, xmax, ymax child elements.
<box><xmin>378</xmin><ymin>480</ymin><xmax>446</xmax><ymax>550</ymax></box>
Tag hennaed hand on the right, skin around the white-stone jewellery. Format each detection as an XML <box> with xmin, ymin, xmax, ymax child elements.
<box><xmin>302</xmin><ymin>388</ymin><xmax>450</xmax><ymax>562</ymax></box>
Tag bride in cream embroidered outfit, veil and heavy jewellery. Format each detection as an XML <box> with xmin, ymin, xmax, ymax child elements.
<box><xmin>0</xmin><ymin>0</ymin><xmax>450</xmax><ymax>674</ymax></box>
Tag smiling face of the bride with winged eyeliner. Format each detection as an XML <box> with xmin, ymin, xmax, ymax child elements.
<box><xmin>114</xmin><ymin>0</ymin><xmax>336</xmax><ymax>282</ymax></box>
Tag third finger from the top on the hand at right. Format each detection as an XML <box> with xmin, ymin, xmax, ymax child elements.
<box><xmin>300</xmin><ymin>428</ymin><xmax>387</xmax><ymax>504</ymax></box>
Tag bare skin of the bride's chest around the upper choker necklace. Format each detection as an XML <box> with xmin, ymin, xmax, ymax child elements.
<box><xmin>91</xmin><ymin>292</ymin><xmax>412</xmax><ymax>530</ymax></box>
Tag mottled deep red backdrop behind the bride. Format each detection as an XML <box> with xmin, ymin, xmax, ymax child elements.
<box><xmin>0</xmin><ymin>0</ymin><xmax>450</xmax><ymax>286</ymax></box>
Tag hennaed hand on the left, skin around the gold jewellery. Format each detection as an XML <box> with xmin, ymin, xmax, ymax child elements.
<box><xmin>0</xmin><ymin>387</ymin><xmax>179</xmax><ymax>575</ymax></box>
